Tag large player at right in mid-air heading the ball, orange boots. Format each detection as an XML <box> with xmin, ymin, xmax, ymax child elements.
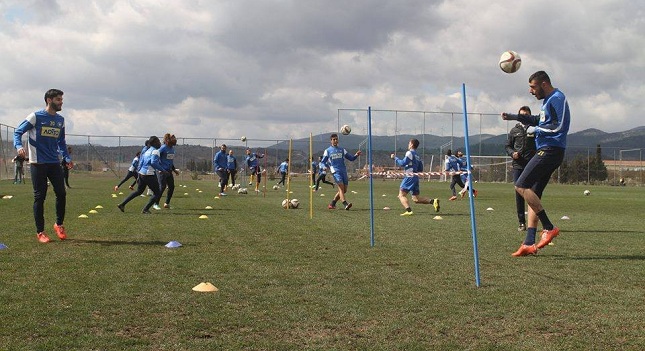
<box><xmin>502</xmin><ymin>71</ymin><xmax>571</xmax><ymax>257</ymax></box>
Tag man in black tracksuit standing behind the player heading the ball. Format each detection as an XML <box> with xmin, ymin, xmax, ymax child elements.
<box><xmin>505</xmin><ymin>106</ymin><xmax>535</xmax><ymax>231</ymax></box>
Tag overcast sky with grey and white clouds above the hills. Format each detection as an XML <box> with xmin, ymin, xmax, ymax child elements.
<box><xmin>0</xmin><ymin>0</ymin><xmax>645</xmax><ymax>146</ymax></box>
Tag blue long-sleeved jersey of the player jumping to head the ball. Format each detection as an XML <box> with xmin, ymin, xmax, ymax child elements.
<box><xmin>516</xmin><ymin>89</ymin><xmax>571</xmax><ymax>150</ymax></box>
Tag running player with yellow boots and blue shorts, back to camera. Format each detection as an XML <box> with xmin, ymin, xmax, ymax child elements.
<box><xmin>390</xmin><ymin>138</ymin><xmax>441</xmax><ymax>216</ymax></box>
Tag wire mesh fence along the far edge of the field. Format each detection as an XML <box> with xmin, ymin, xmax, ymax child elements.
<box><xmin>0</xmin><ymin>124</ymin><xmax>645</xmax><ymax>186</ymax></box>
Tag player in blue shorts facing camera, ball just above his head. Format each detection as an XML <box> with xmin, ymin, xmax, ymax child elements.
<box><xmin>320</xmin><ymin>133</ymin><xmax>361</xmax><ymax>210</ymax></box>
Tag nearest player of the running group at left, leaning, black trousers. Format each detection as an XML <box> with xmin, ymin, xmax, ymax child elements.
<box><xmin>116</xmin><ymin>135</ymin><xmax>165</xmax><ymax>214</ymax></box>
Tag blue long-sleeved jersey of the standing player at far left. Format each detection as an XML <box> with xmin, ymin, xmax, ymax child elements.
<box><xmin>13</xmin><ymin>109</ymin><xmax>72</xmax><ymax>163</ymax></box>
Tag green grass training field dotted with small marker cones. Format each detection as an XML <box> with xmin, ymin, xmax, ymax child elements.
<box><xmin>0</xmin><ymin>174</ymin><xmax>645</xmax><ymax>350</ymax></box>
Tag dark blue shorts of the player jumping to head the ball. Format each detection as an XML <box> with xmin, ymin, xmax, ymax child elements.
<box><xmin>515</xmin><ymin>147</ymin><xmax>564</xmax><ymax>198</ymax></box>
